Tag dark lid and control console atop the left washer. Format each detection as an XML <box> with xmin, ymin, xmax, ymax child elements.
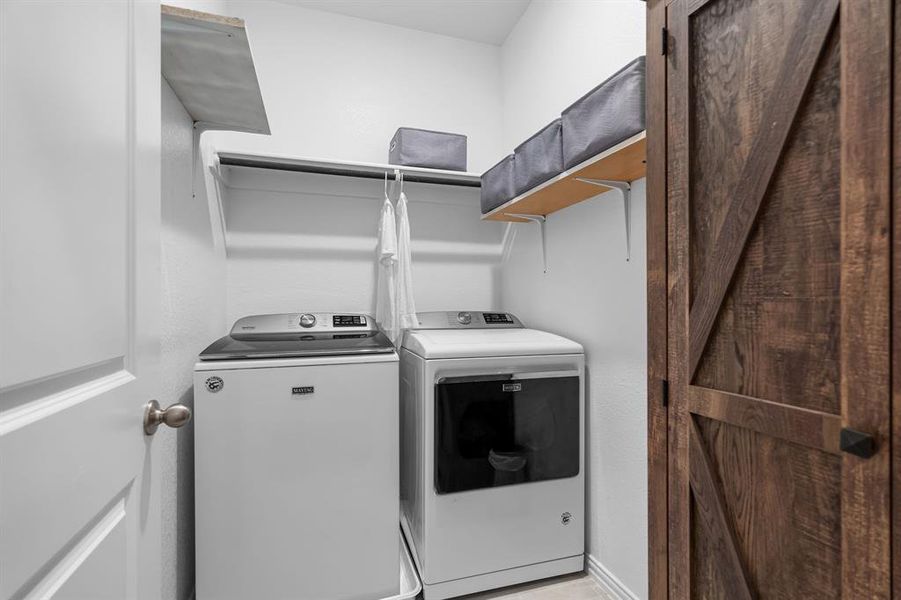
<box><xmin>200</xmin><ymin>313</ymin><xmax>394</xmax><ymax>360</ymax></box>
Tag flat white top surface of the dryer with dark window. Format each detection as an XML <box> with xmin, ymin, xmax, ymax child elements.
<box><xmin>403</xmin><ymin>329</ymin><xmax>584</xmax><ymax>358</ymax></box>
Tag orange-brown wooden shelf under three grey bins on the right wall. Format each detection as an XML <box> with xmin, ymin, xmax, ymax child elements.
<box><xmin>482</xmin><ymin>131</ymin><xmax>646</xmax><ymax>222</ymax></box>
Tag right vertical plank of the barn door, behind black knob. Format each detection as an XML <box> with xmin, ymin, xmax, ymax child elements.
<box><xmin>840</xmin><ymin>0</ymin><xmax>892</xmax><ymax>598</ymax></box>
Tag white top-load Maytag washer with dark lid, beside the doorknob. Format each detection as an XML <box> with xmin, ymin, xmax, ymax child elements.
<box><xmin>194</xmin><ymin>313</ymin><xmax>400</xmax><ymax>600</ymax></box>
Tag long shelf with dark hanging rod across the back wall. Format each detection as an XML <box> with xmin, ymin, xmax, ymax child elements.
<box><xmin>218</xmin><ymin>152</ymin><xmax>481</xmax><ymax>187</ymax></box>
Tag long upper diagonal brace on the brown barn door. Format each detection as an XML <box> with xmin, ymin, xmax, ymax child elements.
<box><xmin>688</xmin><ymin>0</ymin><xmax>838</xmax><ymax>380</ymax></box>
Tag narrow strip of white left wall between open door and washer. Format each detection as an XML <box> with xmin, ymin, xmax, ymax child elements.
<box><xmin>160</xmin><ymin>79</ymin><xmax>226</xmax><ymax>600</ymax></box>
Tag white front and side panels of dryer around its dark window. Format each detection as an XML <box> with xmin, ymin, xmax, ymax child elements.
<box><xmin>401</xmin><ymin>350</ymin><xmax>586</xmax><ymax>599</ymax></box>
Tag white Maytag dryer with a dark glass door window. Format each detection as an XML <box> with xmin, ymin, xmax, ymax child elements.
<box><xmin>400</xmin><ymin>311</ymin><xmax>585</xmax><ymax>600</ymax></box>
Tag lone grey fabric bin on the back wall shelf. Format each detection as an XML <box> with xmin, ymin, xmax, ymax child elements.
<box><xmin>388</xmin><ymin>127</ymin><xmax>466</xmax><ymax>171</ymax></box>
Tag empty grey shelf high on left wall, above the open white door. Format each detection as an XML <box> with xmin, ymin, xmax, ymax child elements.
<box><xmin>161</xmin><ymin>4</ymin><xmax>270</xmax><ymax>135</ymax></box>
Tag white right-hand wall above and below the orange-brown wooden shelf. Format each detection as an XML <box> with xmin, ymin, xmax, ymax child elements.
<box><xmin>501</xmin><ymin>0</ymin><xmax>647</xmax><ymax>597</ymax></box>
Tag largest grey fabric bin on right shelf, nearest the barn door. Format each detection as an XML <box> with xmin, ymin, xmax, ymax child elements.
<box><xmin>563</xmin><ymin>56</ymin><xmax>645</xmax><ymax>169</ymax></box>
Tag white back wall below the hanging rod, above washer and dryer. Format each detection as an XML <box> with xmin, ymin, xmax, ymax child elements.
<box><xmin>224</xmin><ymin>164</ymin><xmax>505</xmax><ymax>321</ymax></box>
